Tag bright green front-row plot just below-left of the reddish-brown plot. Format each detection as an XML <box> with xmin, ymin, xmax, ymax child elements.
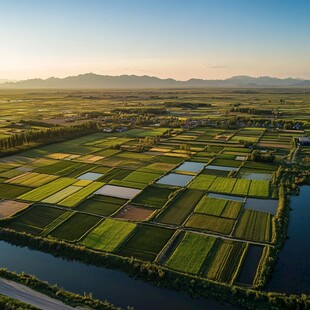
<box><xmin>82</xmin><ymin>219</ymin><xmax>137</xmax><ymax>252</ymax></box>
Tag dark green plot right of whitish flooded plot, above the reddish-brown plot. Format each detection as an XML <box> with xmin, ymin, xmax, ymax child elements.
<box><xmin>133</xmin><ymin>185</ymin><xmax>175</xmax><ymax>209</ymax></box>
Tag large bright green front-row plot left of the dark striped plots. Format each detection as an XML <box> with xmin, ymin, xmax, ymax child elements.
<box><xmin>165</xmin><ymin>232</ymin><xmax>216</xmax><ymax>274</ymax></box>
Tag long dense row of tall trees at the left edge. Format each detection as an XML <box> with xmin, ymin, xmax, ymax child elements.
<box><xmin>0</xmin><ymin>122</ymin><xmax>98</xmax><ymax>151</ymax></box>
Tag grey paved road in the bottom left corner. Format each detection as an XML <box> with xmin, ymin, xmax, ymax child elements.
<box><xmin>0</xmin><ymin>278</ymin><xmax>76</xmax><ymax>310</ymax></box>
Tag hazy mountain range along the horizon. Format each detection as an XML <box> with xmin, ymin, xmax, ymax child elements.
<box><xmin>0</xmin><ymin>73</ymin><xmax>310</xmax><ymax>89</ymax></box>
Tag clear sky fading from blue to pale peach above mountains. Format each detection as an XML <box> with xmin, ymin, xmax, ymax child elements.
<box><xmin>0</xmin><ymin>0</ymin><xmax>310</xmax><ymax>80</ymax></box>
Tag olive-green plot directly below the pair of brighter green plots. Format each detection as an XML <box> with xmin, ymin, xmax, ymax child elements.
<box><xmin>185</xmin><ymin>213</ymin><xmax>235</xmax><ymax>235</ymax></box>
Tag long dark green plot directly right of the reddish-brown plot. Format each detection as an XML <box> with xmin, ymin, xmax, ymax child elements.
<box><xmin>156</xmin><ymin>189</ymin><xmax>203</xmax><ymax>225</ymax></box>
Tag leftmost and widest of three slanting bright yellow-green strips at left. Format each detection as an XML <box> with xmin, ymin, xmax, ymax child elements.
<box><xmin>18</xmin><ymin>178</ymin><xmax>76</xmax><ymax>201</ymax></box>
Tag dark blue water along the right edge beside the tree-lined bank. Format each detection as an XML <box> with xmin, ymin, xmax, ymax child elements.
<box><xmin>267</xmin><ymin>186</ymin><xmax>310</xmax><ymax>294</ymax></box>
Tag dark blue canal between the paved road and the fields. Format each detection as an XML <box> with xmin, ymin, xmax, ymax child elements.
<box><xmin>0</xmin><ymin>241</ymin><xmax>236</xmax><ymax>310</ymax></box>
